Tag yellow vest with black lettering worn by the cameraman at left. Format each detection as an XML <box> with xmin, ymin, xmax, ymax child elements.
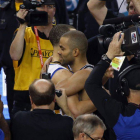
<box><xmin>13</xmin><ymin>27</ymin><xmax>53</xmax><ymax>90</ymax></box>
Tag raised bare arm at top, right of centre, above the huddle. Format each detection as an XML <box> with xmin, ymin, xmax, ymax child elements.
<box><xmin>87</xmin><ymin>0</ymin><xmax>107</xmax><ymax>25</ymax></box>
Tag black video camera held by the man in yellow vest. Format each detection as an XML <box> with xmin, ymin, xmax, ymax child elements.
<box><xmin>20</xmin><ymin>0</ymin><xmax>55</xmax><ymax>26</ymax></box>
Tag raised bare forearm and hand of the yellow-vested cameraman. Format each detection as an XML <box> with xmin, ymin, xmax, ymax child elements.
<box><xmin>10</xmin><ymin>9</ymin><xmax>27</xmax><ymax>60</ymax></box>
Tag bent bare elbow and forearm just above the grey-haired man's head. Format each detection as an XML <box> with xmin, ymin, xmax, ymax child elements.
<box><xmin>67</xmin><ymin>94</ymin><xmax>96</xmax><ymax>118</ymax></box>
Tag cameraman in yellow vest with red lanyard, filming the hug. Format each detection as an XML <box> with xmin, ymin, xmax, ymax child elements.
<box><xmin>10</xmin><ymin>0</ymin><xmax>55</xmax><ymax>114</ymax></box>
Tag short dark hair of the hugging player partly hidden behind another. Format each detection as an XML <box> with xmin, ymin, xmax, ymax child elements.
<box><xmin>49</xmin><ymin>24</ymin><xmax>75</xmax><ymax>46</ymax></box>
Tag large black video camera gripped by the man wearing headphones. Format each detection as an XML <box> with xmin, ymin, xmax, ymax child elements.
<box><xmin>98</xmin><ymin>22</ymin><xmax>140</xmax><ymax>61</ymax></box>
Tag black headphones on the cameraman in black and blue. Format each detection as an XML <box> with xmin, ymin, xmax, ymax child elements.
<box><xmin>117</xmin><ymin>65</ymin><xmax>140</xmax><ymax>97</ymax></box>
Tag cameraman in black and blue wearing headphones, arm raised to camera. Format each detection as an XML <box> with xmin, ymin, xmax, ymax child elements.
<box><xmin>85</xmin><ymin>32</ymin><xmax>140</xmax><ymax>140</ymax></box>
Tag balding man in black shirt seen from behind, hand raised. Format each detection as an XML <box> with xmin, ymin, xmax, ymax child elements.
<box><xmin>12</xmin><ymin>79</ymin><xmax>73</xmax><ymax>140</ymax></box>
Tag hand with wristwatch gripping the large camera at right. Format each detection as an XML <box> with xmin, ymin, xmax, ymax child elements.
<box><xmin>106</xmin><ymin>32</ymin><xmax>124</xmax><ymax>60</ymax></box>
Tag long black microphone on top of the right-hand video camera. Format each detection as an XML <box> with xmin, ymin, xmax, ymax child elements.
<box><xmin>103</xmin><ymin>15</ymin><xmax>140</xmax><ymax>25</ymax></box>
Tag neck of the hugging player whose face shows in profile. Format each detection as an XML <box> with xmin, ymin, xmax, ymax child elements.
<box><xmin>70</xmin><ymin>59</ymin><xmax>88</xmax><ymax>72</ymax></box>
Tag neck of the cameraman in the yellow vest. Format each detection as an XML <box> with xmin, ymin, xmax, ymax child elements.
<box><xmin>37</xmin><ymin>24</ymin><xmax>53</xmax><ymax>37</ymax></box>
